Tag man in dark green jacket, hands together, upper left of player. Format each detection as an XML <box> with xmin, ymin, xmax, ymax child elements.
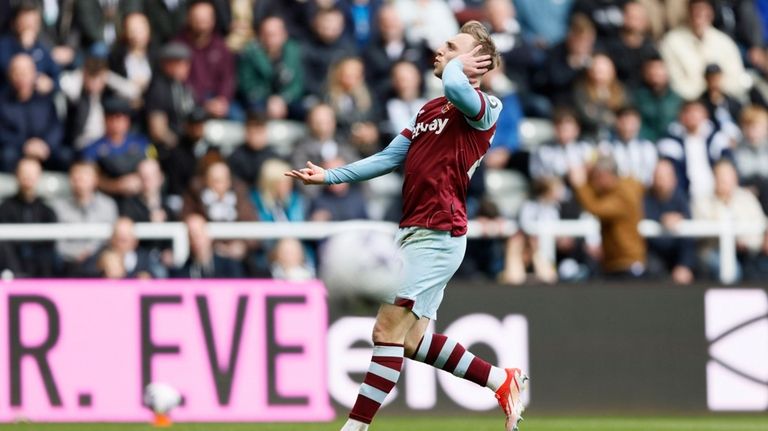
<box><xmin>237</xmin><ymin>17</ymin><xmax>304</xmax><ymax>119</ymax></box>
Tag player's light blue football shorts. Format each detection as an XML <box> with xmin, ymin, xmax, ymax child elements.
<box><xmin>389</xmin><ymin>227</ymin><xmax>467</xmax><ymax>320</ymax></box>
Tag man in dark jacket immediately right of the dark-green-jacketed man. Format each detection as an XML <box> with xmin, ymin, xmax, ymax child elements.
<box><xmin>302</xmin><ymin>8</ymin><xmax>355</xmax><ymax>98</ymax></box>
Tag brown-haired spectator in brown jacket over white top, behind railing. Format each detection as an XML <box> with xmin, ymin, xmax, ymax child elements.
<box><xmin>182</xmin><ymin>160</ymin><xmax>258</xmax><ymax>260</ymax></box>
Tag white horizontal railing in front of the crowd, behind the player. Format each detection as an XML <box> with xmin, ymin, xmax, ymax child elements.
<box><xmin>0</xmin><ymin>219</ymin><xmax>765</xmax><ymax>284</ymax></box>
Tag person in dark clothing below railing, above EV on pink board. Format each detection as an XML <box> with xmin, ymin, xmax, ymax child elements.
<box><xmin>171</xmin><ymin>214</ymin><xmax>245</xmax><ymax>278</ymax></box>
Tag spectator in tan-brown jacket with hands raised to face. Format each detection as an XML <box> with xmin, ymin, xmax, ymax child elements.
<box><xmin>568</xmin><ymin>156</ymin><xmax>646</xmax><ymax>279</ymax></box>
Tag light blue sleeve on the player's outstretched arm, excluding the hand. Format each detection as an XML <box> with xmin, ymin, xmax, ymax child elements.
<box><xmin>325</xmin><ymin>135</ymin><xmax>411</xmax><ymax>184</ymax></box>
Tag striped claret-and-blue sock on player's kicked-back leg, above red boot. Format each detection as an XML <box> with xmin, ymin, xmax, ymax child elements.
<box><xmin>412</xmin><ymin>334</ymin><xmax>507</xmax><ymax>392</ymax></box>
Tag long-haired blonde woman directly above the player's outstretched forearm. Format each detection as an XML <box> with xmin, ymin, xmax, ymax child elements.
<box><xmin>326</xmin><ymin>57</ymin><xmax>380</xmax><ymax>155</ymax></box>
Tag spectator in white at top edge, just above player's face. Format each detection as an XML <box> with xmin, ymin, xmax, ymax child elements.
<box><xmin>393</xmin><ymin>0</ymin><xmax>459</xmax><ymax>51</ymax></box>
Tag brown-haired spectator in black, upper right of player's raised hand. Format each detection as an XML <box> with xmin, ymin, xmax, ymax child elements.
<box><xmin>535</xmin><ymin>15</ymin><xmax>596</xmax><ymax>105</ymax></box>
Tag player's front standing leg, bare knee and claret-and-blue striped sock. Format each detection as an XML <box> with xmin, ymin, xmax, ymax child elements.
<box><xmin>342</xmin><ymin>304</ymin><xmax>416</xmax><ymax>431</ymax></box>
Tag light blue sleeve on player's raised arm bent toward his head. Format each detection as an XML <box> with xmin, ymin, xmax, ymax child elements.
<box><xmin>443</xmin><ymin>58</ymin><xmax>503</xmax><ymax>130</ymax></box>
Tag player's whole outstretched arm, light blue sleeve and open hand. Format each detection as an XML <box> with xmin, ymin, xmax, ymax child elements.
<box><xmin>285</xmin><ymin>135</ymin><xmax>411</xmax><ymax>184</ymax></box>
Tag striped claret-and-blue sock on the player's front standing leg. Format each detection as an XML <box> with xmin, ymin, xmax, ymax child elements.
<box><xmin>343</xmin><ymin>343</ymin><xmax>404</xmax><ymax>430</ymax></box>
